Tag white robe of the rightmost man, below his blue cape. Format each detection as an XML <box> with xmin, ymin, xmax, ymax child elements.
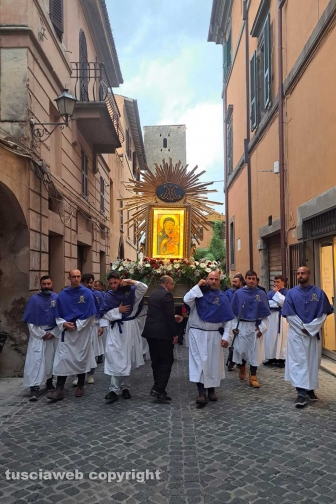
<box><xmin>285</xmin><ymin>314</ymin><xmax>327</xmax><ymax>390</ymax></box>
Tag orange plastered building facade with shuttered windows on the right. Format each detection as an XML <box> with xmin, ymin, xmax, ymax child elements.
<box><xmin>208</xmin><ymin>0</ymin><xmax>336</xmax><ymax>358</ymax></box>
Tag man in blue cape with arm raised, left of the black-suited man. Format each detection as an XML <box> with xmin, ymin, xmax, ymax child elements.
<box><xmin>101</xmin><ymin>271</ymin><xmax>148</xmax><ymax>403</ymax></box>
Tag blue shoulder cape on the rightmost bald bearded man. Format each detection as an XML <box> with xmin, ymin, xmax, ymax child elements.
<box><xmin>282</xmin><ymin>285</ymin><xmax>333</xmax><ymax>324</ymax></box>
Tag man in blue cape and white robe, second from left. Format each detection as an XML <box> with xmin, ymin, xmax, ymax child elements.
<box><xmin>47</xmin><ymin>269</ymin><xmax>98</xmax><ymax>401</ymax></box>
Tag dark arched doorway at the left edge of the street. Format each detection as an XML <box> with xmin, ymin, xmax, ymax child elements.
<box><xmin>0</xmin><ymin>182</ymin><xmax>29</xmax><ymax>376</ymax></box>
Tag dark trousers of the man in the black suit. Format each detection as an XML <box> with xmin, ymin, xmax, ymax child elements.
<box><xmin>147</xmin><ymin>338</ymin><xmax>174</xmax><ymax>394</ymax></box>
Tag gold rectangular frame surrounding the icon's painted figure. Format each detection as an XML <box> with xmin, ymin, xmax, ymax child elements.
<box><xmin>146</xmin><ymin>205</ymin><xmax>190</xmax><ymax>259</ymax></box>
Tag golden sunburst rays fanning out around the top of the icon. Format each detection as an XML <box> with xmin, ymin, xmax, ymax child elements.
<box><xmin>119</xmin><ymin>158</ymin><xmax>220</xmax><ymax>243</ymax></box>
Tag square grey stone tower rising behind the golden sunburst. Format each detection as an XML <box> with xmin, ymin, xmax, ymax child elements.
<box><xmin>144</xmin><ymin>124</ymin><xmax>187</xmax><ymax>171</ymax></box>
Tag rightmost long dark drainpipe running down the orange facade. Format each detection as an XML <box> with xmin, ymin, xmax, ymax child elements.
<box><xmin>278</xmin><ymin>0</ymin><xmax>287</xmax><ymax>278</ymax></box>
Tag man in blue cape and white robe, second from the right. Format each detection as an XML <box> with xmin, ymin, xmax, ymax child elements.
<box><xmin>264</xmin><ymin>275</ymin><xmax>288</xmax><ymax>368</ymax></box>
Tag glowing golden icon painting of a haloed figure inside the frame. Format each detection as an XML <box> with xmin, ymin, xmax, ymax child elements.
<box><xmin>151</xmin><ymin>207</ymin><xmax>186</xmax><ymax>259</ymax></box>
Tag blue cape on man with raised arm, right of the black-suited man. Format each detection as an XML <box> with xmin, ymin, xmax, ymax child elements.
<box><xmin>196</xmin><ymin>290</ymin><xmax>234</xmax><ymax>324</ymax></box>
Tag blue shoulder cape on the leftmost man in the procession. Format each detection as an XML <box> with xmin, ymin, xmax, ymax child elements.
<box><xmin>22</xmin><ymin>292</ymin><xmax>57</xmax><ymax>328</ymax></box>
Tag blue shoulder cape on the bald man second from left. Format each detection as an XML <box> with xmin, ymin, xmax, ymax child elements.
<box><xmin>55</xmin><ymin>285</ymin><xmax>98</xmax><ymax>322</ymax></box>
